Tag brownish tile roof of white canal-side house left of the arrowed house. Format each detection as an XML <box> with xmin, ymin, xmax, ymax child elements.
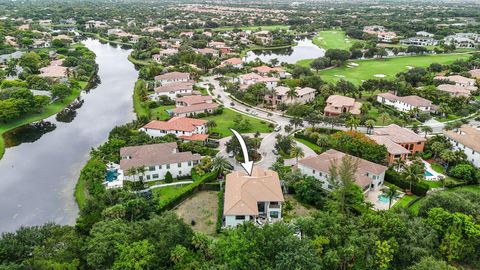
<box><xmin>120</xmin><ymin>142</ymin><xmax>202</xmax><ymax>171</ymax></box>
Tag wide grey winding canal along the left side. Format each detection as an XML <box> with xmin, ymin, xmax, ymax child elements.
<box><xmin>0</xmin><ymin>39</ymin><xmax>138</xmax><ymax>232</ymax></box>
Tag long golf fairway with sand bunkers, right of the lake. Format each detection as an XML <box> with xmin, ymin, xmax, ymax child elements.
<box><xmin>297</xmin><ymin>54</ymin><xmax>470</xmax><ymax>85</ymax></box>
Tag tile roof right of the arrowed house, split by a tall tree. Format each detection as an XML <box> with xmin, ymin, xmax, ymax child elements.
<box><xmin>298</xmin><ymin>149</ymin><xmax>387</xmax><ymax>187</ymax></box>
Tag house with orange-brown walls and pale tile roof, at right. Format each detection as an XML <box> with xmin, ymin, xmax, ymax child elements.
<box><xmin>371</xmin><ymin>124</ymin><xmax>427</xmax><ymax>164</ymax></box>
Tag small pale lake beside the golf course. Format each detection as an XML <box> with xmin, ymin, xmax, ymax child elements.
<box><xmin>243</xmin><ymin>39</ymin><xmax>325</xmax><ymax>64</ymax></box>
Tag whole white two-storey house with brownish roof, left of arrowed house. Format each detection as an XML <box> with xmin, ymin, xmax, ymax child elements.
<box><xmin>120</xmin><ymin>142</ymin><xmax>202</xmax><ymax>181</ymax></box>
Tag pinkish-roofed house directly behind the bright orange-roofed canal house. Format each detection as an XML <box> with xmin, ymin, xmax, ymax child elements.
<box><xmin>171</xmin><ymin>96</ymin><xmax>218</xmax><ymax>117</ymax></box>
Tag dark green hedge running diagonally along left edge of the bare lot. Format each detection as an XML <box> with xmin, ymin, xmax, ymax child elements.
<box><xmin>157</xmin><ymin>169</ymin><xmax>217</xmax><ymax>212</ymax></box>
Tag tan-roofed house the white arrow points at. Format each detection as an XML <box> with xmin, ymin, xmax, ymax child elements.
<box><xmin>223</xmin><ymin>166</ymin><xmax>285</xmax><ymax>227</ymax></box>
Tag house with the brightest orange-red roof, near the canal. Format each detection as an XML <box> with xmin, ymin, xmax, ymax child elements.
<box><xmin>139</xmin><ymin>117</ymin><xmax>208</xmax><ymax>141</ymax></box>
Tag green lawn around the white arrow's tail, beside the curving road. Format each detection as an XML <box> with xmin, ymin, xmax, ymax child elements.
<box><xmin>202</xmin><ymin>108</ymin><xmax>273</xmax><ymax>138</ymax></box>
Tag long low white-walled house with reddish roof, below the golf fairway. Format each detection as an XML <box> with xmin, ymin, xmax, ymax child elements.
<box><xmin>377</xmin><ymin>92</ymin><xmax>435</xmax><ymax>113</ymax></box>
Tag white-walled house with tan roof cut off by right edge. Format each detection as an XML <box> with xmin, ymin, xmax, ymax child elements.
<box><xmin>443</xmin><ymin>125</ymin><xmax>480</xmax><ymax>168</ymax></box>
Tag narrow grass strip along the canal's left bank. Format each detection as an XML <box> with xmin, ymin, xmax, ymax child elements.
<box><xmin>0</xmin><ymin>82</ymin><xmax>88</xmax><ymax>159</ymax></box>
